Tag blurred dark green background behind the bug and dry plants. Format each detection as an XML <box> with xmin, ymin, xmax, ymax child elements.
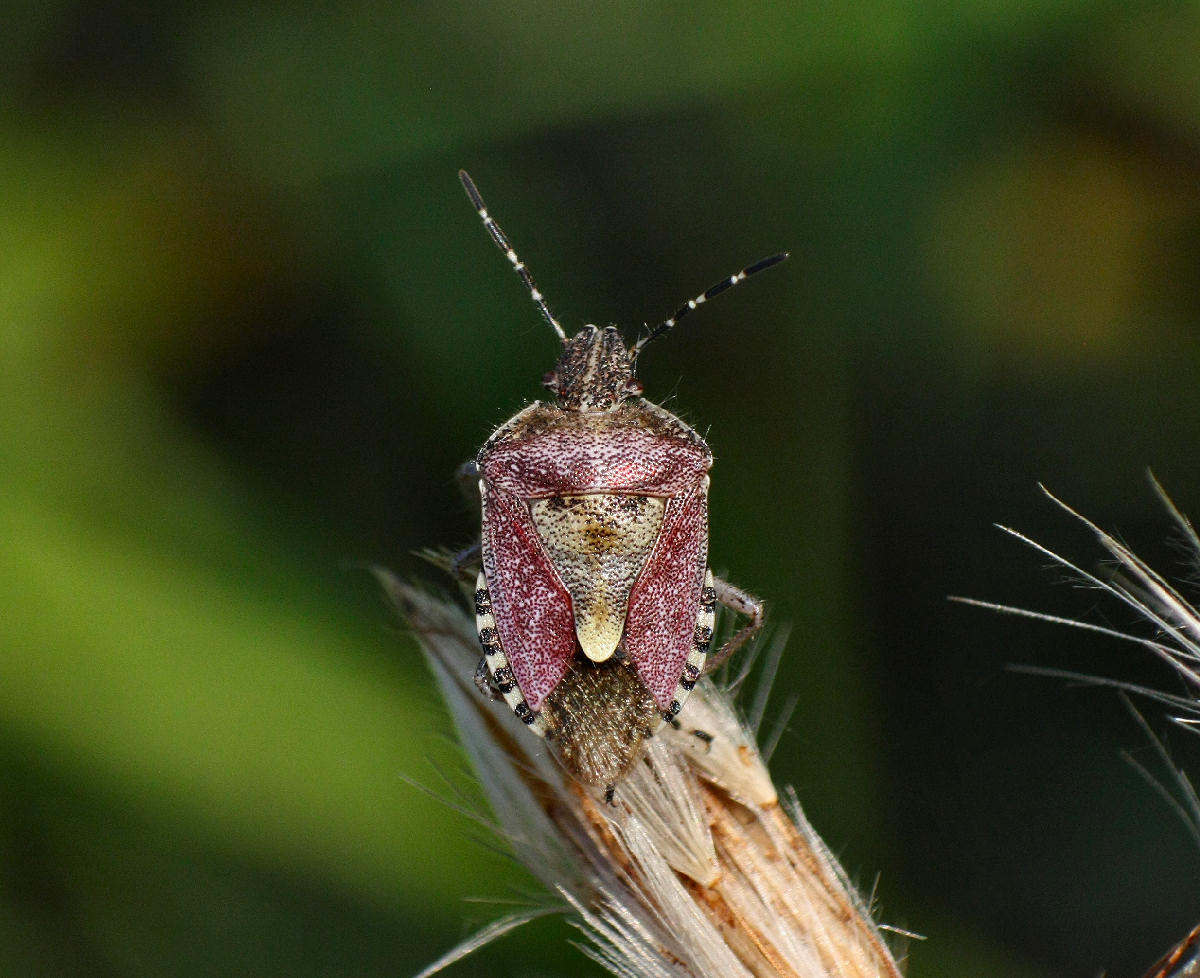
<box><xmin>0</xmin><ymin>0</ymin><xmax>1200</xmax><ymax>978</ymax></box>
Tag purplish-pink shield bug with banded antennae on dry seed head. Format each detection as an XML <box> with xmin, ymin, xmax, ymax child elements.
<box><xmin>458</xmin><ymin>172</ymin><xmax>787</xmax><ymax>799</ymax></box>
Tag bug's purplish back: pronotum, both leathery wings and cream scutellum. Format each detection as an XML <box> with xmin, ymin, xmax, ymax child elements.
<box><xmin>476</xmin><ymin>400</ymin><xmax>713</xmax><ymax>710</ymax></box>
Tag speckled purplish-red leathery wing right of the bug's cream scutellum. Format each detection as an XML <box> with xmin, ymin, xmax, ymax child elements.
<box><xmin>625</xmin><ymin>476</ymin><xmax>708</xmax><ymax>710</ymax></box>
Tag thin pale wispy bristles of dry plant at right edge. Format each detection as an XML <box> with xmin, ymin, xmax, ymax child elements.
<box><xmin>953</xmin><ymin>475</ymin><xmax>1200</xmax><ymax>978</ymax></box>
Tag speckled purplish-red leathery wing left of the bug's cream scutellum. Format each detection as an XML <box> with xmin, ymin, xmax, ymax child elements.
<box><xmin>481</xmin><ymin>486</ymin><xmax>575</xmax><ymax>710</ymax></box>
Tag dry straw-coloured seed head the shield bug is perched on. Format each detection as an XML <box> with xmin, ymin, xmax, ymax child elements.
<box><xmin>378</xmin><ymin>571</ymin><xmax>901</xmax><ymax>978</ymax></box>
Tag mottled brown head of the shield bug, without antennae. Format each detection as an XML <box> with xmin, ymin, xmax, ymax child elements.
<box><xmin>542</xmin><ymin>326</ymin><xmax>642</xmax><ymax>412</ymax></box>
